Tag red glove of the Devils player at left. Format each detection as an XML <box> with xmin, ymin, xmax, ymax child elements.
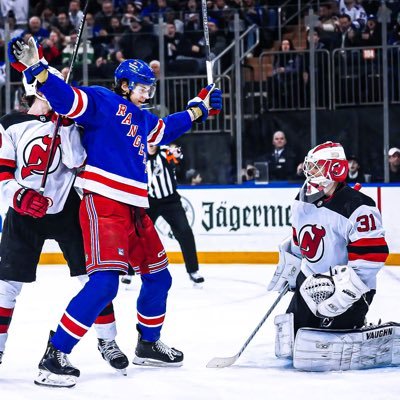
<box><xmin>13</xmin><ymin>188</ymin><xmax>49</xmax><ymax>218</ymax></box>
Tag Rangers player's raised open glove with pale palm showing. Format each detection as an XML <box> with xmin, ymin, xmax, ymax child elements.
<box><xmin>8</xmin><ymin>36</ymin><xmax>48</xmax><ymax>83</ymax></box>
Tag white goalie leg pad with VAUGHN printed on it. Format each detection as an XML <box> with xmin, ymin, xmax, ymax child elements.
<box><xmin>293</xmin><ymin>322</ymin><xmax>400</xmax><ymax>372</ymax></box>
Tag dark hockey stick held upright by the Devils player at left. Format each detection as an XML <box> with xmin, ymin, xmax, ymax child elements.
<box><xmin>39</xmin><ymin>0</ymin><xmax>89</xmax><ymax>194</ymax></box>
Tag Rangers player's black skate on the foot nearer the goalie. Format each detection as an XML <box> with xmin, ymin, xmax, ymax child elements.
<box><xmin>133</xmin><ymin>329</ymin><xmax>183</xmax><ymax>367</ymax></box>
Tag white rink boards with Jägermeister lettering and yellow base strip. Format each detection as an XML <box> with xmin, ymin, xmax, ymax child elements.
<box><xmin>1</xmin><ymin>185</ymin><xmax>400</xmax><ymax>265</ymax></box>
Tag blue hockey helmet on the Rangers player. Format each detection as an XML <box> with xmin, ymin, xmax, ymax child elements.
<box><xmin>114</xmin><ymin>59</ymin><xmax>157</xmax><ymax>98</ymax></box>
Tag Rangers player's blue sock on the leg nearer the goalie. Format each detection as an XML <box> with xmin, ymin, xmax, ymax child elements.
<box><xmin>137</xmin><ymin>269</ymin><xmax>172</xmax><ymax>342</ymax></box>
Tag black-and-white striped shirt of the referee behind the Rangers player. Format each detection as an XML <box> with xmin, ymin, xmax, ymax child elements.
<box><xmin>147</xmin><ymin>147</ymin><xmax>177</xmax><ymax>199</ymax></box>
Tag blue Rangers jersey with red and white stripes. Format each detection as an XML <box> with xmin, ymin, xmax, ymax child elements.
<box><xmin>40</xmin><ymin>73</ymin><xmax>192</xmax><ymax>207</ymax></box>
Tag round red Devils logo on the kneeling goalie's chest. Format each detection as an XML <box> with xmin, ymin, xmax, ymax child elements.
<box><xmin>298</xmin><ymin>225</ymin><xmax>326</xmax><ymax>263</ymax></box>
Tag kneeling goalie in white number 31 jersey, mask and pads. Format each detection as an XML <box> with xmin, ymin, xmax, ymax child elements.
<box><xmin>268</xmin><ymin>142</ymin><xmax>400</xmax><ymax>371</ymax></box>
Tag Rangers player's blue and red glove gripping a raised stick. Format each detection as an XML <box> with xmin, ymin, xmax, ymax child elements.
<box><xmin>186</xmin><ymin>83</ymin><xmax>222</xmax><ymax>122</ymax></box>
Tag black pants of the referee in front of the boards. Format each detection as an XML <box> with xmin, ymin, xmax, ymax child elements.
<box><xmin>146</xmin><ymin>193</ymin><xmax>199</xmax><ymax>273</ymax></box>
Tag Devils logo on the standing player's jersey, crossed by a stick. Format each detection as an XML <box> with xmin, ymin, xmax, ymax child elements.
<box><xmin>21</xmin><ymin>135</ymin><xmax>61</xmax><ymax>179</ymax></box>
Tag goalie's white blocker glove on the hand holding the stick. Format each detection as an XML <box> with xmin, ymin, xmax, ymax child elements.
<box><xmin>267</xmin><ymin>237</ymin><xmax>301</xmax><ymax>293</ymax></box>
